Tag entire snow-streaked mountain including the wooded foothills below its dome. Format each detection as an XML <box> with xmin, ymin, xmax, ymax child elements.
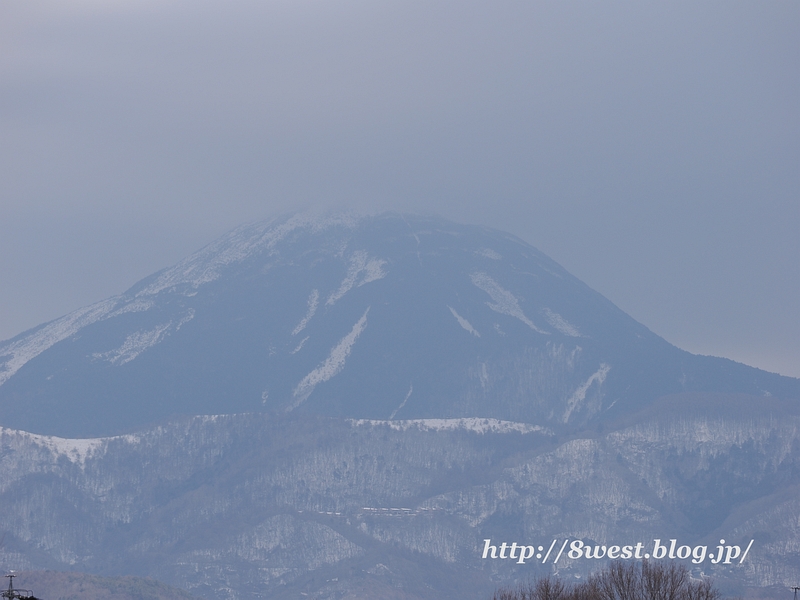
<box><xmin>0</xmin><ymin>213</ymin><xmax>800</xmax><ymax>600</ymax></box>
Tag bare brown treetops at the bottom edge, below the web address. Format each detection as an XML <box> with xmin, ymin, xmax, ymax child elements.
<box><xmin>492</xmin><ymin>561</ymin><xmax>722</xmax><ymax>600</ymax></box>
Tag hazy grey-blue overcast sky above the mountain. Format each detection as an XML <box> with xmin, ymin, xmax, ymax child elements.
<box><xmin>0</xmin><ymin>0</ymin><xmax>800</xmax><ymax>376</ymax></box>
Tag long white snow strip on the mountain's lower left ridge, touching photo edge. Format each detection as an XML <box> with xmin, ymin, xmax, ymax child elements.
<box><xmin>0</xmin><ymin>297</ymin><xmax>119</xmax><ymax>385</ymax></box>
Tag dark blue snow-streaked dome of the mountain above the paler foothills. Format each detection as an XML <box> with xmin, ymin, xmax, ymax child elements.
<box><xmin>0</xmin><ymin>213</ymin><xmax>800</xmax><ymax>437</ymax></box>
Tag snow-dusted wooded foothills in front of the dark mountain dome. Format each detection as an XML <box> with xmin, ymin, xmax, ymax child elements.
<box><xmin>0</xmin><ymin>394</ymin><xmax>800</xmax><ymax>600</ymax></box>
